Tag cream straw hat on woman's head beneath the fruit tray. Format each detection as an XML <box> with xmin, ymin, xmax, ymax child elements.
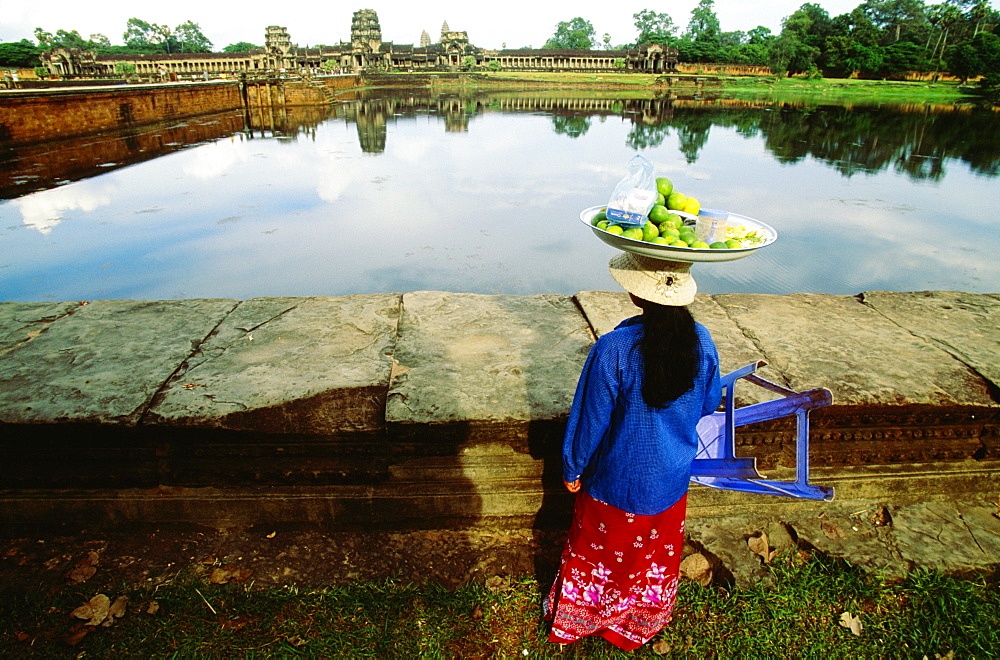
<box><xmin>608</xmin><ymin>252</ymin><xmax>698</xmax><ymax>307</ymax></box>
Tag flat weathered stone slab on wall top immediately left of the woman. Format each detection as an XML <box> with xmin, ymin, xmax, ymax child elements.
<box><xmin>386</xmin><ymin>291</ymin><xmax>593</xmax><ymax>425</ymax></box>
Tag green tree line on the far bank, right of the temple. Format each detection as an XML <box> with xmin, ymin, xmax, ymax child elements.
<box><xmin>545</xmin><ymin>0</ymin><xmax>1000</xmax><ymax>96</ymax></box>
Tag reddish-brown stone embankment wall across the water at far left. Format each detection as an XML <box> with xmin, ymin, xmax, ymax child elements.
<box><xmin>0</xmin><ymin>82</ymin><xmax>243</xmax><ymax>144</ymax></box>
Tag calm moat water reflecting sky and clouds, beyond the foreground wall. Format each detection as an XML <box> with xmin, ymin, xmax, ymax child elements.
<box><xmin>0</xmin><ymin>90</ymin><xmax>1000</xmax><ymax>301</ymax></box>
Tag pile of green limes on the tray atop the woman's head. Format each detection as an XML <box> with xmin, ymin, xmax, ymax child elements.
<box><xmin>591</xmin><ymin>177</ymin><xmax>743</xmax><ymax>250</ymax></box>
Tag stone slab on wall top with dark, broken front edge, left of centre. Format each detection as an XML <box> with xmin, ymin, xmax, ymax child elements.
<box><xmin>147</xmin><ymin>294</ymin><xmax>400</xmax><ymax>435</ymax></box>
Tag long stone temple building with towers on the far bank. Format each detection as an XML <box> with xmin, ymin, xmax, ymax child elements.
<box><xmin>41</xmin><ymin>9</ymin><xmax>677</xmax><ymax>78</ymax></box>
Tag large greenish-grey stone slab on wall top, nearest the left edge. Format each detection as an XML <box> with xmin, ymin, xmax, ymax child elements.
<box><xmin>0</xmin><ymin>299</ymin><xmax>236</xmax><ymax>425</ymax></box>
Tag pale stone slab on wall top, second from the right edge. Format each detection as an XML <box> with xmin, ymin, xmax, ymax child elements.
<box><xmin>714</xmin><ymin>294</ymin><xmax>994</xmax><ymax>407</ymax></box>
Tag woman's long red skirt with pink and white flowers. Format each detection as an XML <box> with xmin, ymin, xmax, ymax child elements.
<box><xmin>543</xmin><ymin>491</ymin><xmax>687</xmax><ymax>651</ymax></box>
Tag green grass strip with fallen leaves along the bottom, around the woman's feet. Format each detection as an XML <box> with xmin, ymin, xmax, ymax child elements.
<box><xmin>0</xmin><ymin>557</ymin><xmax>1000</xmax><ymax>659</ymax></box>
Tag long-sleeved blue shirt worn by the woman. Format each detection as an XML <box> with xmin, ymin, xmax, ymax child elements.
<box><xmin>563</xmin><ymin>316</ymin><xmax>722</xmax><ymax>515</ymax></box>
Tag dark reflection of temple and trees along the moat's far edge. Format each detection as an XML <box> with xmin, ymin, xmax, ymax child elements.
<box><xmin>244</xmin><ymin>90</ymin><xmax>1000</xmax><ymax>180</ymax></box>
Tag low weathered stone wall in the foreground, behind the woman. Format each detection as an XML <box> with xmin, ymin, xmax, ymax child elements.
<box><xmin>0</xmin><ymin>291</ymin><xmax>1000</xmax><ymax>529</ymax></box>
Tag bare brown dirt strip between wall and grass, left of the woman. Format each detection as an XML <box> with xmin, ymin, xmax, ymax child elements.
<box><xmin>0</xmin><ymin>525</ymin><xmax>564</xmax><ymax>593</ymax></box>
